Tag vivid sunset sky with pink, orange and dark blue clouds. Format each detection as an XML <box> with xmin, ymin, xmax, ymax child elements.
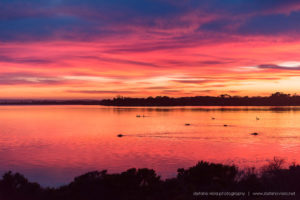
<box><xmin>0</xmin><ymin>0</ymin><xmax>300</xmax><ymax>99</ymax></box>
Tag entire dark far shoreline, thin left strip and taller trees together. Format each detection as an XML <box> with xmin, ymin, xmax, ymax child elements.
<box><xmin>0</xmin><ymin>92</ymin><xmax>300</xmax><ymax>106</ymax></box>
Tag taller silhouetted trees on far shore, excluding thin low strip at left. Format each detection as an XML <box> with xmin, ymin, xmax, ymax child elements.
<box><xmin>101</xmin><ymin>92</ymin><xmax>300</xmax><ymax>106</ymax></box>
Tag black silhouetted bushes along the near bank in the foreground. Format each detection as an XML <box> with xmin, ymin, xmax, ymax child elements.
<box><xmin>0</xmin><ymin>159</ymin><xmax>300</xmax><ymax>200</ymax></box>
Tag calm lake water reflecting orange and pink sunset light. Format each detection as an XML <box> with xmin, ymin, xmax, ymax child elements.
<box><xmin>0</xmin><ymin>106</ymin><xmax>300</xmax><ymax>186</ymax></box>
